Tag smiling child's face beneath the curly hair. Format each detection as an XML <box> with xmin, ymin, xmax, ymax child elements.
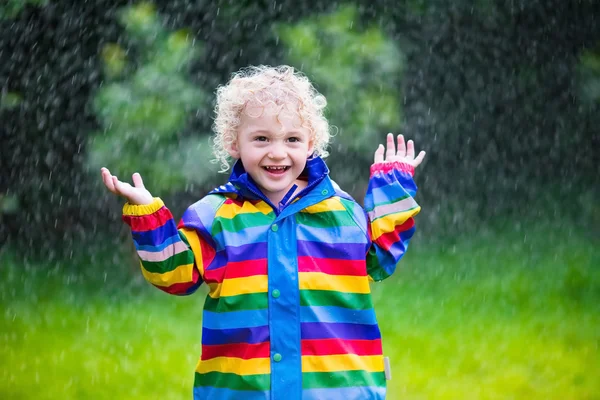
<box><xmin>229</xmin><ymin>104</ymin><xmax>313</xmax><ymax>205</ymax></box>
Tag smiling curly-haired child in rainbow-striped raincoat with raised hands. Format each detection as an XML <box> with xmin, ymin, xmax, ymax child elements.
<box><xmin>102</xmin><ymin>66</ymin><xmax>425</xmax><ymax>400</ymax></box>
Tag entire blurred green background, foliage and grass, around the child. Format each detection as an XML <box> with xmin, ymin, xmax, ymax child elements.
<box><xmin>0</xmin><ymin>0</ymin><xmax>600</xmax><ymax>399</ymax></box>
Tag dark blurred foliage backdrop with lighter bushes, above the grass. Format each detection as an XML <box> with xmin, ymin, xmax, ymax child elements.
<box><xmin>0</xmin><ymin>0</ymin><xmax>600</xmax><ymax>258</ymax></box>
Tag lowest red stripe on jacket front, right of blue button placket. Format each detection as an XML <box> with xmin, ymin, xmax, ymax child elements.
<box><xmin>302</xmin><ymin>339</ymin><xmax>383</xmax><ymax>356</ymax></box>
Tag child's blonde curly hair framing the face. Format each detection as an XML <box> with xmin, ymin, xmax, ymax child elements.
<box><xmin>213</xmin><ymin>65</ymin><xmax>331</xmax><ymax>172</ymax></box>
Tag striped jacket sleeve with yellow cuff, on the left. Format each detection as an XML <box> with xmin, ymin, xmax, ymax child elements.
<box><xmin>123</xmin><ymin>198</ymin><xmax>215</xmax><ymax>295</ymax></box>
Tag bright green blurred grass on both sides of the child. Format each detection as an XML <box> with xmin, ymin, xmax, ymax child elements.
<box><xmin>0</xmin><ymin>221</ymin><xmax>600</xmax><ymax>400</ymax></box>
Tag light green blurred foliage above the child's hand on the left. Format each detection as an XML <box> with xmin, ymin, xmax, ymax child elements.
<box><xmin>88</xmin><ymin>3</ymin><xmax>215</xmax><ymax>195</ymax></box>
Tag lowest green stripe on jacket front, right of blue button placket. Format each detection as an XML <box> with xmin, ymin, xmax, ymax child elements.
<box><xmin>302</xmin><ymin>371</ymin><xmax>385</xmax><ymax>389</ymax></box>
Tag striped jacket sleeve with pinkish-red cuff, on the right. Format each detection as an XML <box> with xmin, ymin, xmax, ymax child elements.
<box><xmin>364</xmin><ymin>162</ymin><xmax>421</xmax><ymax>281</ymax></box>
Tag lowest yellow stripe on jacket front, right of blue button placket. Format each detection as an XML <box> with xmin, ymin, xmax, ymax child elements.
<box><xmin>302</xmin><ymin>354</ymin><xmax>384</xmax><ymax>372</ymax></box>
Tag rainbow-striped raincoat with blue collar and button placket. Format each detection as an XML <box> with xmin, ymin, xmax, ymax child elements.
<box><xmin>123</xmin><ymin>157</ymin><xmax>420</xmax><ymax>400</ymax></box>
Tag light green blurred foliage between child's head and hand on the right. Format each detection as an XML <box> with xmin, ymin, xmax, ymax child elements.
<box><xmin>274</xmin><ymin>5</ymin><xmax>404</xmax><ymax>155</ymax></box>
